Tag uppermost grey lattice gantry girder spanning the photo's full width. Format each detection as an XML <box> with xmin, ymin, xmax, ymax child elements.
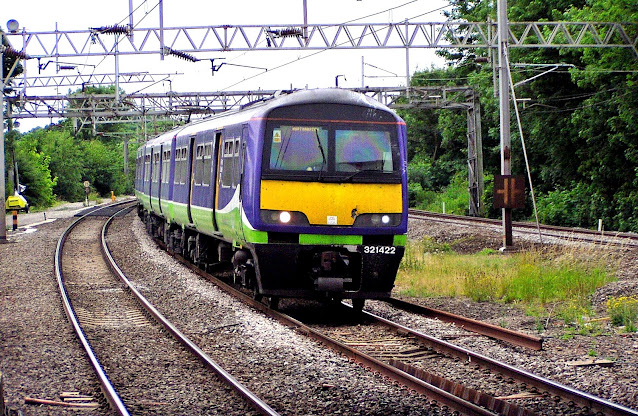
<box><xmin>5</xmin><ymin>21</ymin><xmax>638</xmax><ymax>57</ymax></box>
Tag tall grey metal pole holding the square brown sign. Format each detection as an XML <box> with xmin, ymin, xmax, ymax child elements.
<box><xmin>497</xmin><ymin>0</ymin><xmax>514</xmax><ymax>250</ymax></box>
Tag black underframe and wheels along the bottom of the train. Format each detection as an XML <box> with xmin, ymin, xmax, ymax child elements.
<box><xmin>140</xmin><ymin>209</ymin><xmax>404</xmax><ymax>310</ymax></box>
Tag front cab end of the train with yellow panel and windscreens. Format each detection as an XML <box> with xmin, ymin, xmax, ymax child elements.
<box><xmin>252</xmin><ymin>104</ymin><xmax>407</xmax><ymax>304</ymax></box>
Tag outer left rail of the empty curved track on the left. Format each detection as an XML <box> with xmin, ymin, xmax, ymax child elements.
<box><xmin>54</xmin><ymin>201</ymin><xmax>131</xmax><ymax>416</ymax></box>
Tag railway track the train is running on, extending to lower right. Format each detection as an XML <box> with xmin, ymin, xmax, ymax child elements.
<box><xmin>154</xmin><ymin>236</ymin><xmax>638</xmax><ymax>416</ymax></box>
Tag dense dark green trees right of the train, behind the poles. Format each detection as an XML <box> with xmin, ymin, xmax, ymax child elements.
<box><xmin>401</xmin><ymin>0</ymin><xmax>638</xmax><ymax>231</ymax></box>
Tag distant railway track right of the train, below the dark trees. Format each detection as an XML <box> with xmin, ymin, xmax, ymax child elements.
<box><xmin>409</xmin><ymin>209</ymin><xmax>638</xmax><ymax>247</ymax></box>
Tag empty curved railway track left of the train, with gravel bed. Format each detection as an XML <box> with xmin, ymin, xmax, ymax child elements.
<box><xmin>55</xmin><ymin>205</ymin><xmax>278</xmax><ymax>415</ymax></box>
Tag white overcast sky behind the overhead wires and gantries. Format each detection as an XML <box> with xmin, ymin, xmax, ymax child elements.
<box><xmin>0</xmin><ymin>0</ymin><xmax>449</xmax><ymax>131</ymax></box>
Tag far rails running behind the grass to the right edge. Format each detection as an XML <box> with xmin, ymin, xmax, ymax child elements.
<box><xmin>409</xmin><ymin>209</ymin><xmax>638</xmax><ymax>247</ymax></box>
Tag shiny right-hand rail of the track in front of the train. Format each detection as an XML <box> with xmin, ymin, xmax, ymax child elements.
<box><xmin>362</xmin><ymin>311</ymin><xmax>638</xmax><ymax>416</ymax></box>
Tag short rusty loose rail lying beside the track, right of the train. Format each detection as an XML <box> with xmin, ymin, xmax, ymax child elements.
<box><xmin>381</xmin><ymin>298</ymin><xmax>543</xmax><ymax>351</ymax></box>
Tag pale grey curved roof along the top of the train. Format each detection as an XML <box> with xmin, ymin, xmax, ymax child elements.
<box><xmin>147</xmin><ymin>88</ymin><xmax>398</xmax><ymax>146</ymax></box>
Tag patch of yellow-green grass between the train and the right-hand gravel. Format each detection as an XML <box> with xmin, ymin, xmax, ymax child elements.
<box><xmin>396</xmin><ymin>240</ymin><xmax>615</xmax><ymax>330</ymax></box>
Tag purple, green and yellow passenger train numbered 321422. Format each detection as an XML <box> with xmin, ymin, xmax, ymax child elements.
<box><xmin>135</xmin><ymin>88</ymin><xmax>408</xmax><ymax>310</ymax></box>
